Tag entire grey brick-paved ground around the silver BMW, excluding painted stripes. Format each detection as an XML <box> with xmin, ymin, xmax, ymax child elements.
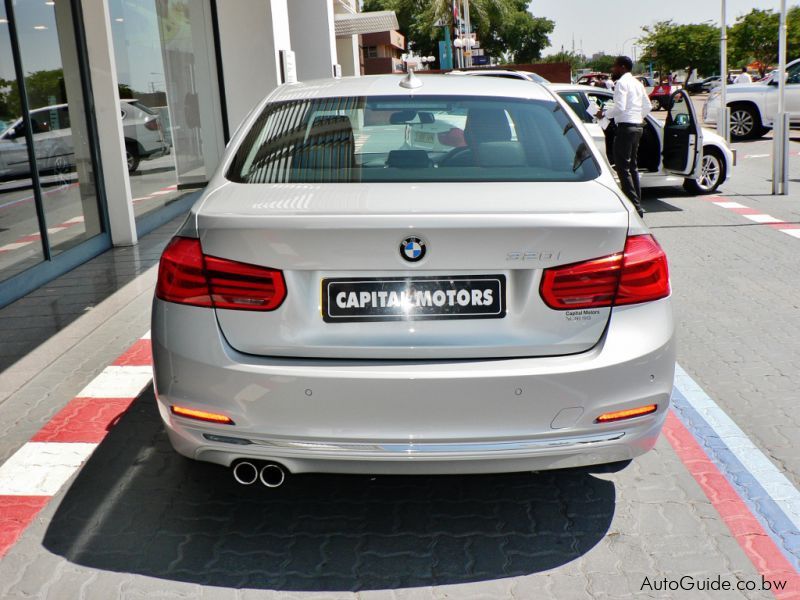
<box><xmin>0</xmin><ymin>127</ymin><xmax>800</xmax><ymax>600</ymax></box>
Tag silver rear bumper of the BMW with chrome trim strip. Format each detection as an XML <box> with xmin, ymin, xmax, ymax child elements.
<box><xmin>152</xmin><ymin>299</ymin><xmax>675</xmax><ymax>474</ymax></box>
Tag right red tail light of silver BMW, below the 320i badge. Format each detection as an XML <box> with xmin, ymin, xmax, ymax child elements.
<box><xmin>539</xmin><ymin>235</ymin><xmax>670</xmax><ymax>310</ymax></box>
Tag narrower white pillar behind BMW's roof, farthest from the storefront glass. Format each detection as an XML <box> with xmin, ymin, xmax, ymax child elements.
<box><xmin>288</xmin><ymin>0</ymin><xmax>338</xmax><ymax>81</ymax></box>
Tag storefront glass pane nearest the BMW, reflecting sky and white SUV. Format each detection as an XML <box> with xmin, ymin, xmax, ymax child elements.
<box><xmin>109</xmin><ymin>0</ymin><xmax>222</xmax><ymax>224</ymax></box>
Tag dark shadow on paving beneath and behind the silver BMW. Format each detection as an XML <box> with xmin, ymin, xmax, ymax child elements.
<box><xmin>44</xmin><ymin>388</ymin><xmax>615</xmax><ymax>591</ymax></box>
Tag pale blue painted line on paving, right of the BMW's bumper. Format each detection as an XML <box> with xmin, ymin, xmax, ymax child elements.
<box><xmin>672</xmin><ymin>380</ymin><xmax>800</xmax><ymax>572</ymax></box>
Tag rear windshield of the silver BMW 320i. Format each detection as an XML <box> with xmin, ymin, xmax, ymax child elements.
<box><xmin>227</xmin><ymin>96</ymin><xmax>599</xmax><ymax>183</ymax></box>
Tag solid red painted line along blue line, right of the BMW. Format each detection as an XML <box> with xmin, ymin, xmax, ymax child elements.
<box><xmin>663</xmin><ymin>411</ymin><xmax>800</xmax><ymax>600</ymax></box>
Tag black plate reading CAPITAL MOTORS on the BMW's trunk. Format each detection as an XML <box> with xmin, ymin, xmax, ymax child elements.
<box><xmin>322</xmin><ymin>275</ymin><xmax>506</xmax><ymax>323</ymax></box>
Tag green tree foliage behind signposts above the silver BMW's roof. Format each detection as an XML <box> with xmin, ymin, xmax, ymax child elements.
<box><xmin>362</xmin><ymin>0</ymin><xmax>555</xmax><ymax>62</ymax></box>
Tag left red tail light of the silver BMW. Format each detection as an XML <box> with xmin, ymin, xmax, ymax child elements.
<box><xmin>156</xmin><ymin>237</ymin><xmax>286</xmax><ymax>311</ymax></box>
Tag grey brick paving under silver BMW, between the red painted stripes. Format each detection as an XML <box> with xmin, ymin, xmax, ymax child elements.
<box><xmin>0</xmin><ymin>390</ymin><xmax>758</xmax><ymax>599</ymax></box>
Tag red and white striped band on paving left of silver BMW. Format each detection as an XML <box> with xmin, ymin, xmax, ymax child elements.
<box><xmin>0</xmin><ymin>332</ymin><xmax>153</xmax><ymax>557</ymax></box>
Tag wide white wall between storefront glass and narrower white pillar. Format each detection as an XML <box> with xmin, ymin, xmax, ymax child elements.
<box><xmin>217</xmin><ymin>0</ymin><xmax>290</xmax><ymax>133</ymax></box>
